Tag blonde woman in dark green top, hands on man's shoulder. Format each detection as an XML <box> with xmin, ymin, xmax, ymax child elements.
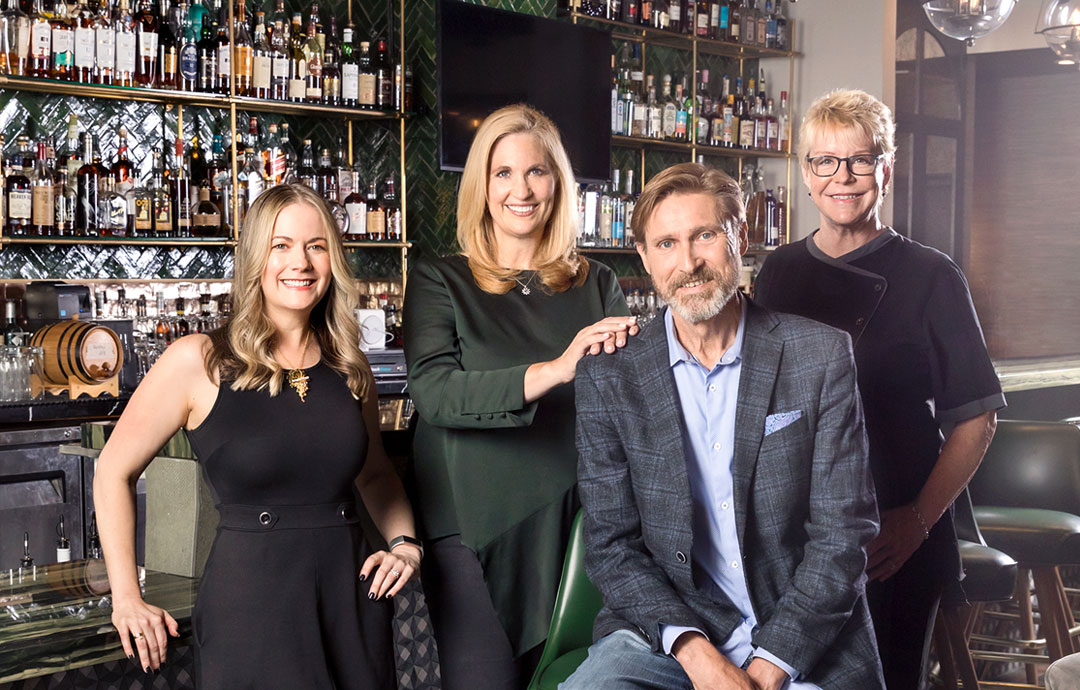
<box><xmin>405</xmin><ymin>105</ymin><xmax>637</xmax><ymax>690</ymax></box>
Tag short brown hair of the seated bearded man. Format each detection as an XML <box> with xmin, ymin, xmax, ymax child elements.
<box><xmin>630</xmin><ymin>163</ymin><xmax>746</xmax><ymax>246</ymax></box>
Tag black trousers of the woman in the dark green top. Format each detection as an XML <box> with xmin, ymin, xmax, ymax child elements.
<box><xmin>421</xmin><ymin>535</ymin><xmax>542</xmax><ymax>690</ymax></box>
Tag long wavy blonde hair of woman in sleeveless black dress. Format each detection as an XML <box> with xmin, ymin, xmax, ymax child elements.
<box><xmin>205</xmin><ymin>185</ymin><xmax>373</xmax><ymax>398</ymax></box>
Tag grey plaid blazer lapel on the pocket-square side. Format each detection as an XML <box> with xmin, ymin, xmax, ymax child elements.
<box><xmin>731</xmin><ymin>301</ymin><xmax>784</xmax><ymax>545</ymax></box>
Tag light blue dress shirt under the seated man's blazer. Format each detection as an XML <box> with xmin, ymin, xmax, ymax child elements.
<box><xmin>661</xmin><ymin>297</ymin><xmax>813</xmax><ymax>688</ymax></box>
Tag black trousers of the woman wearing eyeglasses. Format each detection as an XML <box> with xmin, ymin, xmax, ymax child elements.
<box><xmin>866</xmin><ymin>549</ymin><xmax>944</xmax><ymax>690</ymax></box>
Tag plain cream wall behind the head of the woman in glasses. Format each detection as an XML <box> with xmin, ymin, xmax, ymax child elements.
<box><xmin>761</xmin><ymin>0</ymin><xmax>894</xmax><ymax>240</ymax></box>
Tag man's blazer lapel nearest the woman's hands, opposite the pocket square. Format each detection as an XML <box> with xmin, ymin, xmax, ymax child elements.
<box><xmin>637</xmin><ymin>312</ymin><xmax>691</xmax><ymax>518</ymax></box>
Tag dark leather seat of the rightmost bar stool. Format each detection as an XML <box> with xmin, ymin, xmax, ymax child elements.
<box><xmin>975</xmin><ymin>505</ymin><xmax>1080</xmax><ymax>567</ymax></box>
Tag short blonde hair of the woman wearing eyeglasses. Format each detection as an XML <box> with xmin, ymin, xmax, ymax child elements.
<box><xmin>798</xmin><ymin>89</ymin><xmax>896</xmax><ymax>170</ymax></box>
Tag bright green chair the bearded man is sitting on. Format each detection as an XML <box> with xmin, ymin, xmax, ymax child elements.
<box><xmin>528</xmin><ymin>511</ymin><xmax>604</xmax><ymax>690</ymax></box>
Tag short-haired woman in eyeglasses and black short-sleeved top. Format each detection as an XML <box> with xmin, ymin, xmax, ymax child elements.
<box><xmin>755</xmin><ymin>91</ymin><xmax>1004</xmax><ymax>690</ymax></box>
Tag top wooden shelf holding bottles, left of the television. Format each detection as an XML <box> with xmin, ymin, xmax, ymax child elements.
<box><xmin>0</xmin><ymin>76</ymin><xmax>408</xmax><ymax>120</ymax></box>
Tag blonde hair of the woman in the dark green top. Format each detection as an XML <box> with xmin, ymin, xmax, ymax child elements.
<box><xmin>458</xmin><ymin>104</ymin><xmax>589</xmax><ymax>295</ymax></box>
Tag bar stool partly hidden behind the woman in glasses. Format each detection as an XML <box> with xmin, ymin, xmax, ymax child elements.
<box><xmin>934</xmin><ymin>489</ymin><xmax>1016</xmax><ymax>690</ymax></box>
